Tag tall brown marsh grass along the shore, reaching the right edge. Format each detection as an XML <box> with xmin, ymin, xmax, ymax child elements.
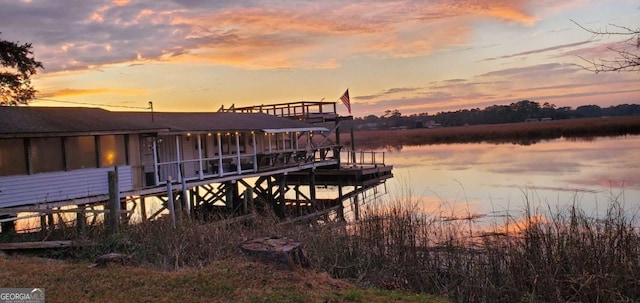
<box><xmin>32</xmin><ymin>192</ymin><xmax>640</xmax><ymax>302</ymax></box>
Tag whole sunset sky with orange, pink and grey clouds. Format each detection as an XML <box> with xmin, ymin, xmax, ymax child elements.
<box><xmin>0</xmin><ymin>0</ymin><xmax>640</xmax><ymax>117</ymax></box>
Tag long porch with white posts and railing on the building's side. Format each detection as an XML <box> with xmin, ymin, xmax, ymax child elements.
<box><xmin>148</xmin><ymin>130</ymin><xmax>340</xmax><ymax>186</ymax></box>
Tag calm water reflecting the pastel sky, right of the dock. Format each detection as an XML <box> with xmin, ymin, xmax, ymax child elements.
<box><xmin>386</xmin><ymin>136</ymin><xmax>640</xmax><ymax>222</ymax></box>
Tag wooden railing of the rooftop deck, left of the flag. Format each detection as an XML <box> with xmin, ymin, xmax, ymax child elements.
<box><xmin>222</xmin><ymin>101</ymin><xmax>338</xmax><ymax>122</ymax></box>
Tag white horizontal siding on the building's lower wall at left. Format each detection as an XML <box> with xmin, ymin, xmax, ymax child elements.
<box><xmin>0</xmin><ymin>166</ymin><xmax>133</xmax><ymax>208</ymax></box>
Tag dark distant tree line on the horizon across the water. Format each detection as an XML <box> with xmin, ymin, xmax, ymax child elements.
<box><xmin>349</xmin><ymin>100</ymin><xmax>640</xmax><ymax>129</ymax></box>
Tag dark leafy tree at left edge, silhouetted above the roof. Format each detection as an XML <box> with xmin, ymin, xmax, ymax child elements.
<box><xmin>0</xmin><ymin>33</ymin><xmax>44</xmax><ymax>106</ymax></box>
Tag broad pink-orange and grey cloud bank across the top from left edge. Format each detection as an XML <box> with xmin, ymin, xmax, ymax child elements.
<box><xmin>0</xmin><ymin>0</ymin><xmax>536</xmax><ymax>72</ymax></box>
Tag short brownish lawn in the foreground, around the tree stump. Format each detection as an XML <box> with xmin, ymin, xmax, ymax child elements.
<box><xmin>0</xmin><ymin>256</ymin><xmax>446</xmax><ymax>302</ymax></box>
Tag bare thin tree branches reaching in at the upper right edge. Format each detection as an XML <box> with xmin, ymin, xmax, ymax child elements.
<box><xmin>571</xmin><ymin>20</ymin><xmax>640</xmax><ymax>73</ymax></box>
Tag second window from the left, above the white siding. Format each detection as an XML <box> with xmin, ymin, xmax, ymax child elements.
<box><xmin>29</xmin><ymin>138</ymin><xmax>64</xmax><ymax>173</ymax></box>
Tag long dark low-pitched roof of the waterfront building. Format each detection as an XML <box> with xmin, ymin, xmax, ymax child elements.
<box><xmin>0</xmin><ymin>106</ymin><xmax>326</xmax><ymax>137</ymax></box>
